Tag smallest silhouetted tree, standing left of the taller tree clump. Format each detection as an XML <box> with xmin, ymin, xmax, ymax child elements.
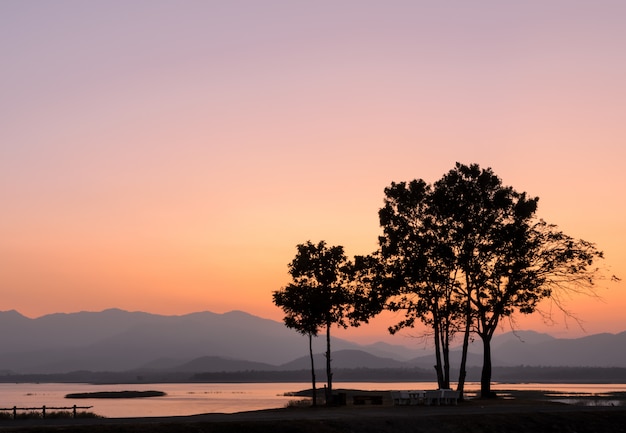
<box><xmin>274</xmin><ymin>241</ymin><xmax>355</xmax><ymax>404</ymax></box>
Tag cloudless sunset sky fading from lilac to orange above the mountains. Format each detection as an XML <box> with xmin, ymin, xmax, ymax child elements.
<box><xmin>0</xmin><ymin>0</ymin><xmax>626</xmax><ymax>344</ymax></box>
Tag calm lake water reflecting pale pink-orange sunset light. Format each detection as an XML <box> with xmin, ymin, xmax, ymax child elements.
<box><xmin>0</xmin><ymin>382</ymin><xmax>626</xmax><ymax>417</ymax></box>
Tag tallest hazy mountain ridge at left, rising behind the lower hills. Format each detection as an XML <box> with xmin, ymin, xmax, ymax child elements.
<box><xmin>0</xmin><ymin>309</ymin><xmax>410</xmax><ymax>373</ymax></box>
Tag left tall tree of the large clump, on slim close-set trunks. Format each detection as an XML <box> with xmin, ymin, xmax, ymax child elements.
<box><xmin>372</xmin><ymin>180</ymin><xmax>460</xmax><ymax>388</ymax></box>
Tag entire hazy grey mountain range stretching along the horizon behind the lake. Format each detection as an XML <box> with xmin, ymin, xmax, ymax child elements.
<box><xmin>0</xmin><ymin>309</ymin><xmax>626</xmax><ymax>374</ymax></box>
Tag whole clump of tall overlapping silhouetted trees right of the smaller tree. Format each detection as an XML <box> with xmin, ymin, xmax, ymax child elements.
<box><xmin>373</xmin><ymin>163</ymin><xmax>602</xmax><ymax>397</ymax></box>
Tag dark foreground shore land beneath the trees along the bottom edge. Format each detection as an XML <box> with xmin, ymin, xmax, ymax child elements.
<box><xmin>0</xmin><ymin>392</ymin><xmax>626</xmax><ymax>433</ymax></box>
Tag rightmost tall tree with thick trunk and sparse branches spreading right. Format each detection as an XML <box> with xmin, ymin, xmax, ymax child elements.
<box><xmin>433</xmin><ymin>164</ymin><xmax>602</xmax><ymax>397</ymax></box>
